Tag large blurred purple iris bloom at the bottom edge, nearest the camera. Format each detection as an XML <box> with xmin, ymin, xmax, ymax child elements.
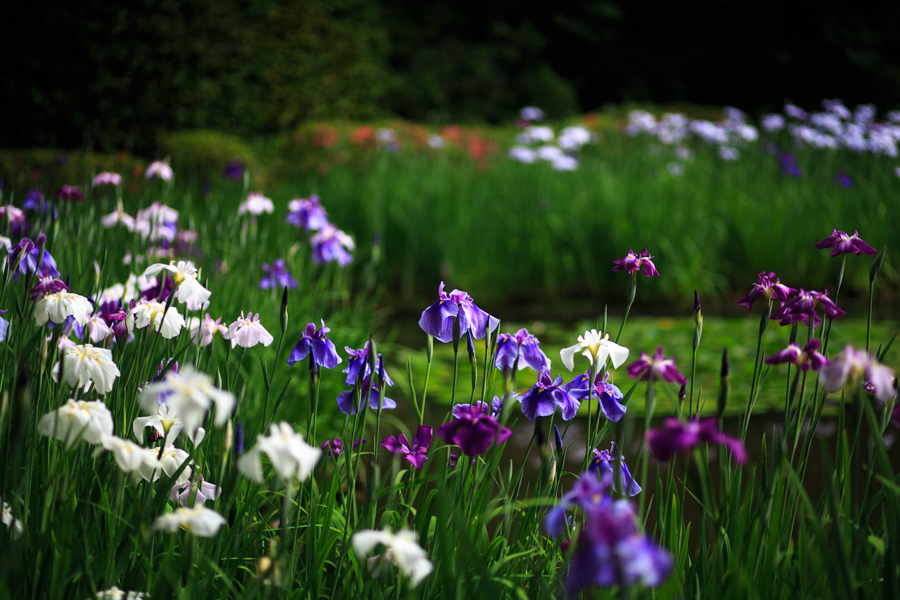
<box><xmin>566</xmin><ymin>500</ymin><xmax>673</xmax><ymax>595</ymax></box>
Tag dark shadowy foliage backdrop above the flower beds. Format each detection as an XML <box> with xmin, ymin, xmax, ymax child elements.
<box><xmin>0</xmin><ymin>0</ymin><xmax>900</xmax><ymax>153</ymax></box>
